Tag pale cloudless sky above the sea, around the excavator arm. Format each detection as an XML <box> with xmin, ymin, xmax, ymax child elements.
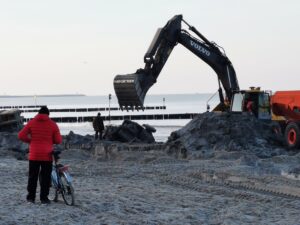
<box><xmin>0</xmin><ymin>0</ymin><xmax>300</xmax><ymax>95</ymax></box>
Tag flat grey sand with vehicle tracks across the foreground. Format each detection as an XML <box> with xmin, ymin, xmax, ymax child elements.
<box><xmin>0</xmin><ymin>144</ymin><xmax>300</xmax><ymax>225</ymax></box>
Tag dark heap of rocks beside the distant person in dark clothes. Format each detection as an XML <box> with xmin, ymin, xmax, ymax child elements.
<box><xmin>104</xmin><ymin>120</ymin><xmax>155</xmax><ymax>143</ymax></box>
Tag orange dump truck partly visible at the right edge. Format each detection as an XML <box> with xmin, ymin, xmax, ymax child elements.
<box><xmin>271</xmin><ymin>91</ymin><xmax>300</xmax><ymax>148</ymax></box>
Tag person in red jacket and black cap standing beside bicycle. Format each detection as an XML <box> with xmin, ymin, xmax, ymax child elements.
<box><xmin>18</xmin><ymin>106</ymin><xmax>62</xmax><ymax>204</ymax></box>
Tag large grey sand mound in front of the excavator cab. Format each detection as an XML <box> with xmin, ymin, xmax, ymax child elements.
<box><xmin>167</xmin><ymin>113</ymin><xmax>285</xmax><ymax>158</ymax></box>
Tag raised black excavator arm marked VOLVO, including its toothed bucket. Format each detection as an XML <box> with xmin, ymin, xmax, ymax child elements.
<box><xmin>114</xmin><ymin>15</ymin><xmax>239</xmax><ymax>110</ymax></box>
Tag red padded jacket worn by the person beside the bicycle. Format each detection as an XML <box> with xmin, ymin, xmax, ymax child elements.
<box><xmin>18</xmin><ymin>114</ymin><xmax>62</xmax><ymax>161</ymax></box>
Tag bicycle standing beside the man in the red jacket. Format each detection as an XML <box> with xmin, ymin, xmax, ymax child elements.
<box><xmin>49</xmin><ymin>151</ymin><xmax>75</xmax><ymax>205</ymax></box>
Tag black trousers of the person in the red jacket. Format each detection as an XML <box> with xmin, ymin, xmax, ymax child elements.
<box><xmin>27</xmin><ymin>160</ymin><xmax>52</xmax><ymax>200</ymax></box>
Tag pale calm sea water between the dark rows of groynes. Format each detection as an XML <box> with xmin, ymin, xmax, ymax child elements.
<box><xmin>0</xmin><ymin>94</ymin><xmax>219</xmax><ymax>141</ymax></box>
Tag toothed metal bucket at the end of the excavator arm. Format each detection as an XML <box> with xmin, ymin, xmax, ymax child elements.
<box><xmin>114</xmin><ymin>73</ymin><xmax>154</xmax><ymax>110</ymax></box>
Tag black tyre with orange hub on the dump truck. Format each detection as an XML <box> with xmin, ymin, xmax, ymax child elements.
<box><xmin>284</xmin><ymin>122</ymin><xmax>300</xmax><ymax>149</ymax></box>
